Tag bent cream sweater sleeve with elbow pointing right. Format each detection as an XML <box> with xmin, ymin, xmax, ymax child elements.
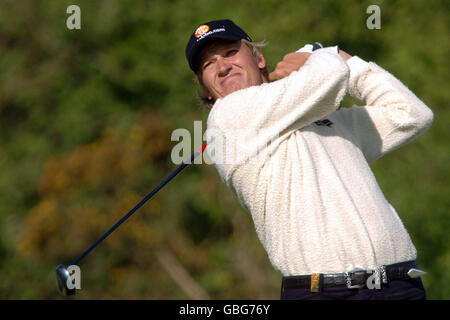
<box><xmin>338</xmin><ymin>56</ymin><xmax>433</xmax><ymax>163</ymax></box>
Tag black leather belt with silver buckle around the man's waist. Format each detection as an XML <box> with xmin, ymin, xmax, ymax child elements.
<box><xmin>282</xmin><ymin>260</ymin><xmax>417</xmax><ymax>292</ymax></box>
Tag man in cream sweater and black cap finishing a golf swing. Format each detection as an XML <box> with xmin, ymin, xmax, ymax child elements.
<box><xmin>186</xmin><ymin>20</ymin><xmax>433</xmax><ymax>299</ymax></box>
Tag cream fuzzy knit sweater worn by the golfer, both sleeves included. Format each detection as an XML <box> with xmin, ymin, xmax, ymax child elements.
<box><xmin>206</xmin><ymin>48</ymin><xmax>433</xmax><ymax>276</ymax></box>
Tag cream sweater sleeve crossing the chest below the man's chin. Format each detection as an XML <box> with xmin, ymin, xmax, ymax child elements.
<box><xmin>208</xmin><ymin>48</ymin><xmax>350</xmax><ymax>172</ymax></box>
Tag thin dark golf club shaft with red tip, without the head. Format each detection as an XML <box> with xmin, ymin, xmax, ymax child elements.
<box><xmin>72</xmin><ymin>143</ymin><xmax>207</xmax><ymax>265</ymax></box>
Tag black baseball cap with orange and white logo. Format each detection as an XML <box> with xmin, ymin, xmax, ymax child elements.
<box><xmin>186</xmin><ymin>19</ymin><xmax>252</xmax><ymax>72</ymax></box>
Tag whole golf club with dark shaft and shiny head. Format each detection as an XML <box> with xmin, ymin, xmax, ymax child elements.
<box><xmin>56</xmin><ymin>143</ymin><xmax>207</xmax><ymax>296</ymax></box>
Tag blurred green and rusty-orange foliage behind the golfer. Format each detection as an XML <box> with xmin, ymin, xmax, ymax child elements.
<box><xmin>0</xmin><ymin>0</ymin><xmax>450</xmax><ymax>299</ymax></box>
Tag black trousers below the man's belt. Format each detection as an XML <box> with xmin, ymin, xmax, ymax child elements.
<box><xmin>281</xmin><ymin>278</ymin><xmax>426</xmax><ymax>300</ymax></box>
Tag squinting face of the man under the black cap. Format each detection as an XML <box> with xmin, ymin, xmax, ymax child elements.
<box><xmin>197</xmin><ymin>40</ymin><xmax>267</xmax><ymax>100</ymax></box>
